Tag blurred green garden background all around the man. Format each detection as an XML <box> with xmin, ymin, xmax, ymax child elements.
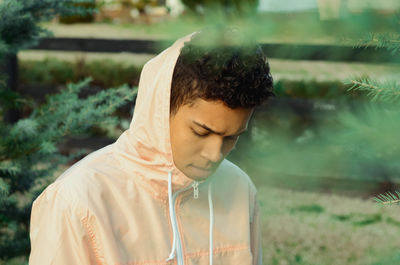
<box><xmin>0</xmin><ymin>0</ymin><xmax>400</xmax><ymax>265</ymax></box>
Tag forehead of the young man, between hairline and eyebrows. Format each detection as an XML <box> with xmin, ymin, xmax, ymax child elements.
<box><xmin>177</xmin><ymin>98</ymin><xmax>253</xmax><ymax>133</ymax></box>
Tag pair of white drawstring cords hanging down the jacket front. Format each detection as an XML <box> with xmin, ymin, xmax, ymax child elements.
<box><xmin>166</xmin><ymin>171</ymin><xmax>214</xmax><ymax>265</ymax></box>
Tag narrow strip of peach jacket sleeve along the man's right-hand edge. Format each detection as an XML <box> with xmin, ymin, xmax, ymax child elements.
<box><xmin>250</xmin><ymin>194</ymin><xmax>263</xmax><ymax>265</ymax></box>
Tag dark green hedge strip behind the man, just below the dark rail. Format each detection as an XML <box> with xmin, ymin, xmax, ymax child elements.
<box><xmin>19</xmin><ymin>58</ymin><xmax>382</xmax><ymax>100</ymax></box>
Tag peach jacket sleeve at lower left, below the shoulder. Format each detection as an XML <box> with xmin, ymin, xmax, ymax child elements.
<box><xmin>29</xmin><ymin>186</ymin><xmax>99</xmax><ymax>265</ymax></box>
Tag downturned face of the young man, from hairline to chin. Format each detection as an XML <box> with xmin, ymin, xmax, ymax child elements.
<box><xmin>170</xmin><ymin>99</ymin><xmax>253</xmax><ymax>180</ymax></box>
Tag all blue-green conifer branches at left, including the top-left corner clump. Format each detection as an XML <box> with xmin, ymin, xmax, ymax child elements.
<box><xmin>0</xmin><ymin>0</ymin><xmax>135</xmax><ymax>263</ymax></box>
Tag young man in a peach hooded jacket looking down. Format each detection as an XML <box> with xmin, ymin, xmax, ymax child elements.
<box><xmin>29</xmin><ymin>29</ymin><xmax>272</xmax><ymax>265</ymax></box>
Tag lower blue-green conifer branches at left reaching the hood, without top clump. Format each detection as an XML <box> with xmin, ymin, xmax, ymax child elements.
<box><xmin>0</xmin><ymin>79</ymin><xmax>136</xmax><ymax>260</ymax></box>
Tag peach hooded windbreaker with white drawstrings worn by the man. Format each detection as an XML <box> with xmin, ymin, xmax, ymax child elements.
<box><xmin>29</xmin><ymin>35</ymin><xmax>262</xmax><ymax>265</ymax></box>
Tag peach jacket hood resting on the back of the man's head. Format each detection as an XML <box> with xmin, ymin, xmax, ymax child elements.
<box><xmin>114</xmin><ymin>33</ymin><xmax>195</xmax><ymax>199</ymax></box>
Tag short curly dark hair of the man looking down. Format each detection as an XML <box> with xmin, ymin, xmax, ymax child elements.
<box><xmin>170</xmin><ymin>29</ymin><xmax>274</xmax><ymax>115</ymax></box>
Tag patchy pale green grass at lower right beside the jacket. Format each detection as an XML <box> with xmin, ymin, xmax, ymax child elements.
<box><xmin>258</xmin><ymin>186</ymin><xmax>400</xmax><ymax>265</ymax></box>
